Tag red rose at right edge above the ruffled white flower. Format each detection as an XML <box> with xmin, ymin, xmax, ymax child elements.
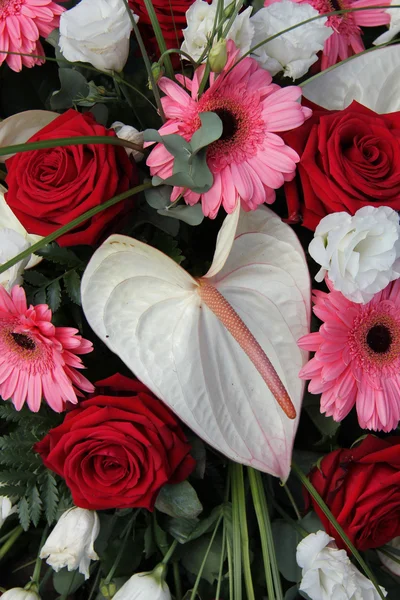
<box><xmin>282</xmin><ymin>101</ymin><xmax>400</xmax><ymax>230</ymax></box>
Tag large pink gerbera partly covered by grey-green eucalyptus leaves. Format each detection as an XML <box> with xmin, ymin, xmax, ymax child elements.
<box><xmin>147</xmin><ymin>40</ymin><xmax>311</xmax><ymax>218</ymax></box>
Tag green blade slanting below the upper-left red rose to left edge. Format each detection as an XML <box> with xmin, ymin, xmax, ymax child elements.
<box><xmin>0</xmin><ymin>181</ymin><xmax>152</xmax><ymax>273</ymax></box>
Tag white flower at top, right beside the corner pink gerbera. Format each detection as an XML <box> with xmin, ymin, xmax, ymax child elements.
<box><xmin>59</xmin><ymin>0</ymin><xmax>139</xmax><ymax>71</ymax></box>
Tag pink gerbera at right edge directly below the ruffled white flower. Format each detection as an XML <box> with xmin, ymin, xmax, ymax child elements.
<box><xmin>298</xmin><ymin>279</ymin><xmax>400</xmax><ymax>431</ymax></box>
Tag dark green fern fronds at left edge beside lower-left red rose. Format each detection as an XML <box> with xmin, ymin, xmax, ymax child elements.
<box><xmin>0</xmin><ymin>402</ymin><xmax>62</xmax><ymax>530</ymax></box>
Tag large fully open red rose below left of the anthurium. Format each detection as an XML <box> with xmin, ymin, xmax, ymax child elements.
<box><xmin>34</xmin><ymin>375</ymin><xmax>195</xmax><ymax>510</ymax></box>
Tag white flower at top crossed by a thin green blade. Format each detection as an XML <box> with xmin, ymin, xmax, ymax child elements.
<box><xmin>250</xmin><ymin>0</ymin><xmax>333</xmax><ymax>79</ymax></box>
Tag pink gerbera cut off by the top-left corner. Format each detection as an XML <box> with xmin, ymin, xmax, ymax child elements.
<box><xmin>0</xmin><ymin>0</ymin><xmax>65</xmax><ymax>71</ymax></box>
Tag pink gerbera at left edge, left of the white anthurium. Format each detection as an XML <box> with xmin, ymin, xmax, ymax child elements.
<box><xmin>0</xmin><ymin>285</ymin><xmax>94</xmax><ymax>412</ymax></box>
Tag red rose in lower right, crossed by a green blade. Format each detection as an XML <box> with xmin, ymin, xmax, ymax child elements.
<box><xmin>309</xmin><ymin>435</ymin><xmax>400</xmax><ymax>550</ymax></box>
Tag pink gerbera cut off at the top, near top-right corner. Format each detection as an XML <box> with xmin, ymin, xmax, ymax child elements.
<box><xmin>264</xmin><ymin>0</ymin><xmax>391</xmax><ymax>70</ymax></box>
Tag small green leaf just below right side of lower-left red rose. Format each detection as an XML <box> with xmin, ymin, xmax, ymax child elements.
<box><xmin>155</xmin><ymin>481</ymin><xmax>203</xmax><ymax>518</ymax></box>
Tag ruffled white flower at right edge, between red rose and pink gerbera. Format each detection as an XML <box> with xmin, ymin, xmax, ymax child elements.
<box><xmin>308</xmin><ymin>206</ymin><xmax>400</xmax><ymax>304</ymax></box>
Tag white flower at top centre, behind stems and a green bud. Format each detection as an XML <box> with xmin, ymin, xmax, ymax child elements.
<box><xmin>182</xmin><ymin>0</ymin><xmax>254</xmax><ymax>60</ymax></box>
